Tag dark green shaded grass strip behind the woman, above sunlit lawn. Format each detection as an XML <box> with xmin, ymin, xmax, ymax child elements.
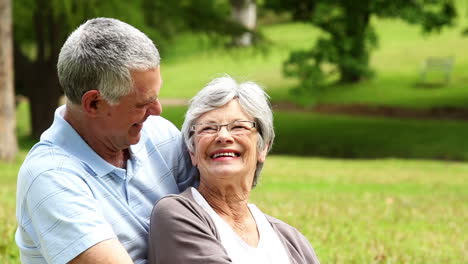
<box><xmin>162</xmin><ymin>107</ymin><xmax>468</xmax><ymax>160</ymax></box>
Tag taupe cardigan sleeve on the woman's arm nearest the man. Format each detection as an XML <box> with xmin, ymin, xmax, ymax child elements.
<box><xmin>148</xmin><ymin>196</ymin><xmax>232</xmax><ymax>264</ymax></box>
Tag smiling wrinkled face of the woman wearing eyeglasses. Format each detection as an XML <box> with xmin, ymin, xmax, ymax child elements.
<box><xmin>191</xmin><ymin>99</ymin><xmax>266</xmax><ymax>186</ymax></box>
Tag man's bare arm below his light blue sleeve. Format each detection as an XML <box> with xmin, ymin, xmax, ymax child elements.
<box><xmin>69</xmin><ymin>238</ymin><xmax>133</xmax><ymax>264</ymax></box>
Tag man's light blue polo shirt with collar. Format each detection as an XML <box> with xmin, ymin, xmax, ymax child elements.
<box><xmin>15</xmin><ymin>106</ymin><xmax>196</xmax><ymax>264</ymax></box>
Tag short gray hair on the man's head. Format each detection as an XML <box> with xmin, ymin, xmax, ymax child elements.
<box><xmin>57</xmin><ymin>18</ymin><xmax>160</xmax><ymax>104</ymax></box>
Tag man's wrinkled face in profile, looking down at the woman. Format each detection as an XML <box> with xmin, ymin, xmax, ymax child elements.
<box><xmin>100</xmin><ymin>66</ymin><xmax>162</xmax><ymax>150</ymax></box>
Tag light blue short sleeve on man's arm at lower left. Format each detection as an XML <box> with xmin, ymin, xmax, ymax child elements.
<box><xmin>17</xmin><ymin>170</ymin><xmax>116</xmax><ymax>263</ymax></box>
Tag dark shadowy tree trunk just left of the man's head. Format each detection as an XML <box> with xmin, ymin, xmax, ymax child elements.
<box><xmin>15</xmin><ymin>0</ymin><xmax>65</xmax><ymax>139</ymax></box>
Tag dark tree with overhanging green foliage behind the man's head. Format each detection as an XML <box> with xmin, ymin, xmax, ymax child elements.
<box><xmin>14</xmin><ymin>0</ymin><xmax>245</xmax><ymax>138</ymax></box>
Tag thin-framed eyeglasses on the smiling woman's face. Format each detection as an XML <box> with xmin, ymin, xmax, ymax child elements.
<box><xmin>190</xmin><ymin>120</ymin><xmax>257</xmax><ymax>136</ymax></box>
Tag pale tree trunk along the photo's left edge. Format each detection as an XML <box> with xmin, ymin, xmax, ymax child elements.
<box><xmin>0</xmin><ymin>0</ymin><xmax>18</xmax><ymax>161</ymax></box>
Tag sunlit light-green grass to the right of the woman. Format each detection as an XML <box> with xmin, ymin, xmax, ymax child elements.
<box><xmin>252</xmin><ymin>156</ymin><xmax>468</xmax><ymax>264</ymax></box>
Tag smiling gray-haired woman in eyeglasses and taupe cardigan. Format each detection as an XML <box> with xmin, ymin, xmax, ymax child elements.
<box><xmin>149</xmin><ymin>77</ymin><xmax>319</xmax><ymax>264</ymax></box>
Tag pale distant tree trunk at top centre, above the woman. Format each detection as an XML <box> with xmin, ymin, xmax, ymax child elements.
<box><xmin>230</xmin><ymin>0</ymin><xmax>257</xmax><ymax>46</ymax></box>
